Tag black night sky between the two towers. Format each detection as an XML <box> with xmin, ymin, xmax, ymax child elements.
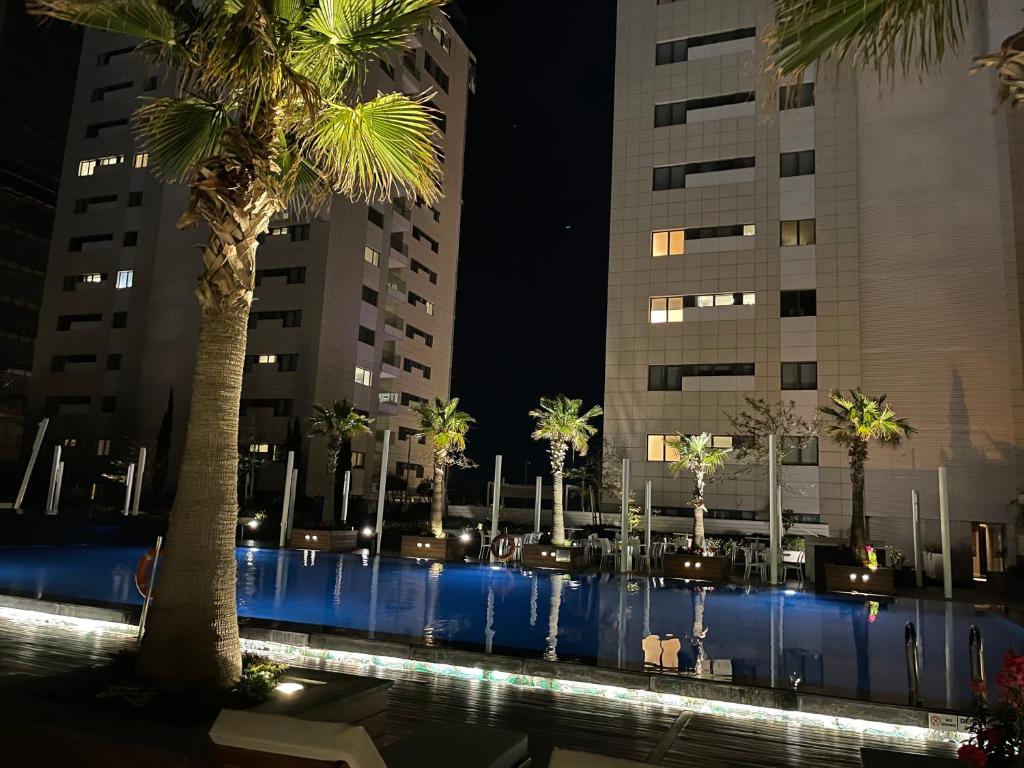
<box><xmin>452</xmin><ymin>0</ymin><xmax>615</xmax><ymax>486</ymax></box>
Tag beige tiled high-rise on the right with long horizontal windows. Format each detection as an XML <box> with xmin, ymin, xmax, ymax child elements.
<box><xmin>605</xmin><ymin>0</ymin><xmax>1024</xmax><ymax>575</ymax></box>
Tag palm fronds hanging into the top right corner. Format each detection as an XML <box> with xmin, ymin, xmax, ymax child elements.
<box><xmin>765</xmin><ymin>0</ymin><xmax>1024</xmax><ymax>106</ymax></box>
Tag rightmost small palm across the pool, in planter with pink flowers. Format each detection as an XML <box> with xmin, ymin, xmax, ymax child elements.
<box><xmin>821</xmin><ymin>389</ymin><xmax>918</xmax><ymax>560</ymax></box>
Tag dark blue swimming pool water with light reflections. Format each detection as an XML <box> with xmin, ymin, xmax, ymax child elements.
<box><xmin>0</xmin><ymin>547</ymin><xmax>1024</xmax><ymax>708</ymax></box>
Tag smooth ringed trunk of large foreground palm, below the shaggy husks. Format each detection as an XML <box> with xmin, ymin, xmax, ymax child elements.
<box><xmin>138</xmin><ymin>305</ymin><xmax>249</xmax><ymax>688</ymax></box>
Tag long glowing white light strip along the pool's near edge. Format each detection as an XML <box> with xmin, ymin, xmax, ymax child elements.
<box><xmin>0</xmin><ymin>607</ymin><xmax>968</xmax><ymax>741</ymax></box>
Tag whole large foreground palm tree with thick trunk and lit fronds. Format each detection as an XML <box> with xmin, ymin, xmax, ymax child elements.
<box><xmin>29</xmin><ymin>0</ymin><xmax>441</xmax><ymax>688</ymax></box>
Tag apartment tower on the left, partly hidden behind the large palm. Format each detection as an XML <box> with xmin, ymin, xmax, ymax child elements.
<box><xmin>33</xmin><ymin>14</ymin><xmax>474</xmax><ymax>512</ymax></box>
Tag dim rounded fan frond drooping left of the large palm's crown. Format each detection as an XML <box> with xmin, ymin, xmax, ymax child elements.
<box><xmin>133</xmin><ymin>97</ymin><xmax>230</xmax><ymax>181</ymax></box>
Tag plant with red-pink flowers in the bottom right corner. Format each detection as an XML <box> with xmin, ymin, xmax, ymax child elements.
<box><xmin>956</xmin><ymin>650</ymin><xmax>1024</xmax><ymax>768</ymax></box>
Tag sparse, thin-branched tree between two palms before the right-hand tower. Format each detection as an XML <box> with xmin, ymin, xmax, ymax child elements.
<box><xmin>725</xmin><ymin>395</ymin><xmax>821</xmax><ymax>487</ymax></box>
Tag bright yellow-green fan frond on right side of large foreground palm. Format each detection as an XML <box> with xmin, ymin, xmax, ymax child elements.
<box><xmin>299</xmin><ymin>93</ymin><xmax>441</xmax><ymax>203</ymax></box>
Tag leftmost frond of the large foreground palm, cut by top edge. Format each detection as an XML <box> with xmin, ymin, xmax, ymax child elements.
<box><xmin>26</xmin><ymin>0</ymin><xmax>176</xmax><ymax>45</ymax></box>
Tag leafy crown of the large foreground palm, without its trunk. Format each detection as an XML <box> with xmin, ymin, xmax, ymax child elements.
<box><xmin>29</xmin><ymin>0</ymin><xmax>443</xmax><ymax>210</ymax></box>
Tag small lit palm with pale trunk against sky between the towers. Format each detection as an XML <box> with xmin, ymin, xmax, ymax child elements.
<box><xmin>529</xmin><ymin>394</ymin><xmax>604</xmax><ymax>544</ymax></box>
